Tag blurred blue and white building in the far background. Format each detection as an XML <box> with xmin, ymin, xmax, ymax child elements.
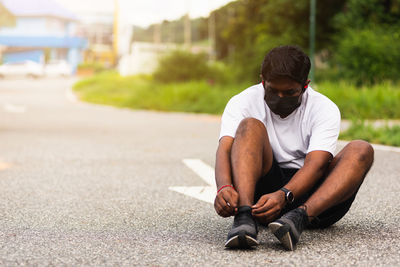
<box><xmin>0</xmin><ymin>0</ymin><xmax>87</xmax><ymax>72</ymax></box>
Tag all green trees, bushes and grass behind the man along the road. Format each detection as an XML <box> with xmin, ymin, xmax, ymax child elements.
<box><xmin>74</xmin><ymin>0</ymin><xmax>400</xmax><ymax>146</ymax></box>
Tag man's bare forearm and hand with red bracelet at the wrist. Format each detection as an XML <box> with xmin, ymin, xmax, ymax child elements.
<box><xmin>214</xmin><ymin>136</ymin><xmax>239</xmax><ymax>217</ymax></box>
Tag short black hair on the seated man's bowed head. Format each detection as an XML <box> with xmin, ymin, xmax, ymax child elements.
<box><xmin>261</xmin><ymin>45</ymin><xmax>311</xmax><ymax>85</ymax></box>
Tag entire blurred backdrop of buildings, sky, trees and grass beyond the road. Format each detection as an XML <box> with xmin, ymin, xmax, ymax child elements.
<box><xmin>0</xmin><ymin>0</ymin><xmax>400</xmax><ymax>146</ymax></box>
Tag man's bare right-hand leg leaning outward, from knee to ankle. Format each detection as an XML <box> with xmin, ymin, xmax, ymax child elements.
<box><xmin>305</xmin><ymin>140</ymin><xmax>374</xmax><ymax>220</ymax></box>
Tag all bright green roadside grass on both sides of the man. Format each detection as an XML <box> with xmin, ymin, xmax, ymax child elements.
<box><xmin>74</xmin><ymin>72</ymin><xmax>400</xmax><ymax>146</ymax></box>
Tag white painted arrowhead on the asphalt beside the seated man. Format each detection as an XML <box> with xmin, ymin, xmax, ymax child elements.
<box><xmin>169</xmin><ymin>159</ymin><xmax>217</xmax><ymax>204</ymax></box>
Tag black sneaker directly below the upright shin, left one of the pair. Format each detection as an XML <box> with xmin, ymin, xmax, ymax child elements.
<box><xmin>225</xmin><ymin>206</ymin><xmax>258</xmax><ymax>248</ymax></box>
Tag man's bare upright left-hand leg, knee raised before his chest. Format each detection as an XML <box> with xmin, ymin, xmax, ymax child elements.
<box><xmin>231</xmin><ymin>118</ymin><xmax>272</xmax><ymax>206</ymax></box>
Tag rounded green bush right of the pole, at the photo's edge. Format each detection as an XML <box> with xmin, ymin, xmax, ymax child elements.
<box><xmin>335</xmin><ymin>27</ymin><xmax>400</xmax><ymax>84</ymax></box>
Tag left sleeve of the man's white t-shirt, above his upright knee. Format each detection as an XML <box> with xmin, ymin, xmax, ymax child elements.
<box><xmin>219</xmin><ymin>96</ymin><xmax>245</xmax><ymax>139</ymax></box>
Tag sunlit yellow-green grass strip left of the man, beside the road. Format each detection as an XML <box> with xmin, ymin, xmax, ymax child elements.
<box><xmin>74</xmin><ymin>72</ymin><xmax>245</xmax><ymax>114</ymax></box>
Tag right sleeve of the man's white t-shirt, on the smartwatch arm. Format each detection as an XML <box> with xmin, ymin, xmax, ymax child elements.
<box><xmin>307</xmin><ymin>103</ymin><xmax>340</xmax><ymax>155</ymax></box>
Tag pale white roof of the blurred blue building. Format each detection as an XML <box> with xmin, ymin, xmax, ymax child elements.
<box><xmin>0</xmin><ymin>0</ymin><xmax>78</xmax><ymax>20</ymax></box>
